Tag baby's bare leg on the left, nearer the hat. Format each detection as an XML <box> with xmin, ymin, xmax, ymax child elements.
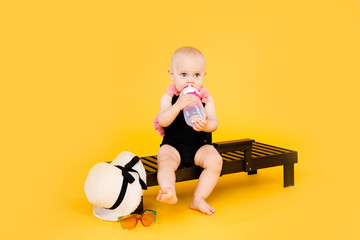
<box><xmin>156</xmin><ymin>144</ymin><xmax>180</xmax><ymax>204</ymax></box>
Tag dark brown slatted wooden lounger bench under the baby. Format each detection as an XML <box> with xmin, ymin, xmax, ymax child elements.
<box><xmin>140</xmin><ymin>138</ymin><xmax>298</xmax><ymax>187</ymax></box>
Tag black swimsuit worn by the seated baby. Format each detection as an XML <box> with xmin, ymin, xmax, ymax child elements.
<box><xmin>160</xmin><ymin>95</ymin><xmax>207</xmax><ymax>168</ymax></box>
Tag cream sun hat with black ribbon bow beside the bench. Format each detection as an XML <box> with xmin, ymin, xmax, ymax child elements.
<box><xmin>85</xmin><ymin>151</ymin><xmax>146</xmax><ymax>221</ymax></box>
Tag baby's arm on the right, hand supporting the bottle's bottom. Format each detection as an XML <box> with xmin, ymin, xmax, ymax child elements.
<box><xmin>194</xmin><ymin>96</ymin><xmax>219</xmax><ymax>132</ymax></box>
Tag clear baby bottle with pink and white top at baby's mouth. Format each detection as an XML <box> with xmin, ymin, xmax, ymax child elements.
<box><xmin>183</xmin><ymin>83</ymin><xmax>206</xmax><ymax>127</ymax></box>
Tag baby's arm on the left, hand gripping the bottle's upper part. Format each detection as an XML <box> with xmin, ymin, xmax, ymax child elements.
<box><xmin>158</xmin><ymin>93</ymin><xmax>198</xmax><ymax>127</ymax></box>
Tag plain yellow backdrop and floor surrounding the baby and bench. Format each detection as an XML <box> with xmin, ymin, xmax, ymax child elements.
<box><xmin>0</xmin><ymin>0</ymin><xmax>360</xmax><ymax>239</ymax></box>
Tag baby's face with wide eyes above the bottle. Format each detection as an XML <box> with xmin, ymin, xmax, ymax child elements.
<box><xmin>169</xmin><ymin>54</ymin><xmax>206</xmax><ymax>92</ymax></box>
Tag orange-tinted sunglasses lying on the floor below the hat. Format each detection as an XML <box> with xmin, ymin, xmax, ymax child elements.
<box><xmin>119</xmin><ymin>209</ymin><xmax>156</xmax><ymax>230</ymax></box>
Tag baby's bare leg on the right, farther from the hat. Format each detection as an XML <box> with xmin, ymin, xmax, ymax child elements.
<box><xmin>190</xmin><ymin>145</ymin><xmax>222</xmax><ymax>215</ymax></box>
